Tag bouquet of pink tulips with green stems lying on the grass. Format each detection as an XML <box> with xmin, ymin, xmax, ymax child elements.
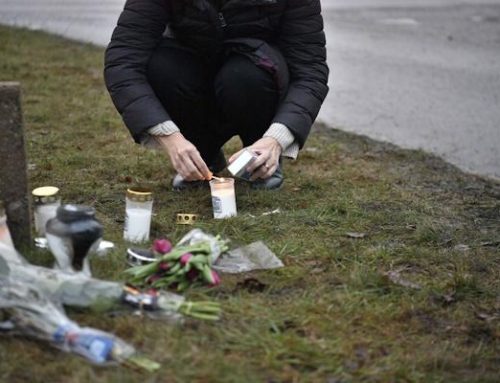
<box><xmin>125</xmin><ymin>229</ymin><xmax>228</xmax><ymax>291</ymax></box>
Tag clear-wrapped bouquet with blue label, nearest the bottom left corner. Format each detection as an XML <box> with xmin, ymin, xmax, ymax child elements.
<box><xmin>0</xmin><ymin>277</ymin><xmax>160</xmax><ymax>371</ymax></box>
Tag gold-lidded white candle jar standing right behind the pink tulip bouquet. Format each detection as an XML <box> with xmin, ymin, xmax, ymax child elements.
<box><xmin>123</xmin><ymin>188</ymin><xmax>153</xmax><ymax>243</ymax></box>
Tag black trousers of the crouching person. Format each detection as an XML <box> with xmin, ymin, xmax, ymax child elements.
<box><xmin>147</xmin><ymin>42</ymin><xmax>286</xmax><ymax>165</ymax></box>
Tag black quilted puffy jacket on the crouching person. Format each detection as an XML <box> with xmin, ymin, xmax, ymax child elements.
<box><xmin>104</xmin><ymin>0</ymin><xmax>328</xmax><ymax>146</ymax></box>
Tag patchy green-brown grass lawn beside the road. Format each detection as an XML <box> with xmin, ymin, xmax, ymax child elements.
<box><xmin>0</xmin><ymin>27</ymin><xmax>500</xmax><ymax>383</ymax></box>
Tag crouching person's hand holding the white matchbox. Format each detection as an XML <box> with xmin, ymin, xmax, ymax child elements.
<box><xmin>229</xmin><ymin>137</ymin><xmax>282</xmax><ymax>181</ymax></box>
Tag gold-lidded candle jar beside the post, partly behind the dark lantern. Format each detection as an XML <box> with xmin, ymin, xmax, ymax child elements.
<box><xmin>32</xmin><ymin>186</ymin><xmax>61</xmax><ymax>237</ymax></box>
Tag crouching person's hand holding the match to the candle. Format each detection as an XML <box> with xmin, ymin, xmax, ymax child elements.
<box><xmin>156</xmin><ymin>132</ymin><xmax>212</xmax><ymax>181</ymax></box>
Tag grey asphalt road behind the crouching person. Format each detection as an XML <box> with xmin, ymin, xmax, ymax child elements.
<box><xmin>0</xmin><ymin>0</ymin><xmax>500</xmax><ymax>178</ymax></box>
